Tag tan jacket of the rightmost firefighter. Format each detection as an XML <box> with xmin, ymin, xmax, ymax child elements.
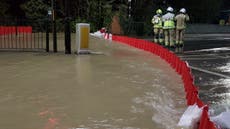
<box><xmin>175</xmin><ymin>13</ymin><xmax>189</xmax><ymax>29</ymax></box>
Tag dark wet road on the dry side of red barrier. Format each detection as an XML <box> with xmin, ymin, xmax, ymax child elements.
<box><xmin>179</xmin><ymin>34</ymin><xmax>230</xmax><ymax>114</ymax></box>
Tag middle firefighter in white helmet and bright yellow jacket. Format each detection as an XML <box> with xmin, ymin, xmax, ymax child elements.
<box><xmin>162</xmin><ymin>7</ymin><xmax>175</xmax><ymax>51</ymax></box>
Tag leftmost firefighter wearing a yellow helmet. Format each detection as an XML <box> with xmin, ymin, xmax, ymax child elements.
<box><xmin>152</xmin><ymin>9</ymin><xmax>163</xmax><ymax>45</ymax></box>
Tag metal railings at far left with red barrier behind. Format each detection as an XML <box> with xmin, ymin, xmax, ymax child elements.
<box><xmin>0</xmin><ymin>18</ymin><xmax>48</xmax><ymax>51</ymax></box>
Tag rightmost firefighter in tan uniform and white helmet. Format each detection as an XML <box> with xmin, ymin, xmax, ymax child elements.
<box><xmin>175</xmin><ymin>8</ymin><xmax>189</xmax><ymax>53</ymax></box>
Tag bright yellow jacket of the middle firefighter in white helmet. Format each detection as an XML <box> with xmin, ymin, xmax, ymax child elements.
<box><xmin>162</xmin><ymin>12</ymin><xmax>175</xmax><ymax>29</ymax></box>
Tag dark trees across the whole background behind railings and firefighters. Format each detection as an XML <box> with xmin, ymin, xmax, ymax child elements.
<box><xmin>0</xmin><ymin>0</ymin><xmax>227</xmax><ymax>34</ymax></box>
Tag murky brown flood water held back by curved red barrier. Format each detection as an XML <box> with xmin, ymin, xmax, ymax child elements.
<box><xmin>0</xmin><ymin>38</ymin><xmax>186</xmax><ymax>129</ymax></box>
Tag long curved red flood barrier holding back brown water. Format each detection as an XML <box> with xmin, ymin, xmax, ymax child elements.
<box><xmin>112</xmin><ymin>35</ymin><xmax>216</xmax><ymax>129</ymax></box>
